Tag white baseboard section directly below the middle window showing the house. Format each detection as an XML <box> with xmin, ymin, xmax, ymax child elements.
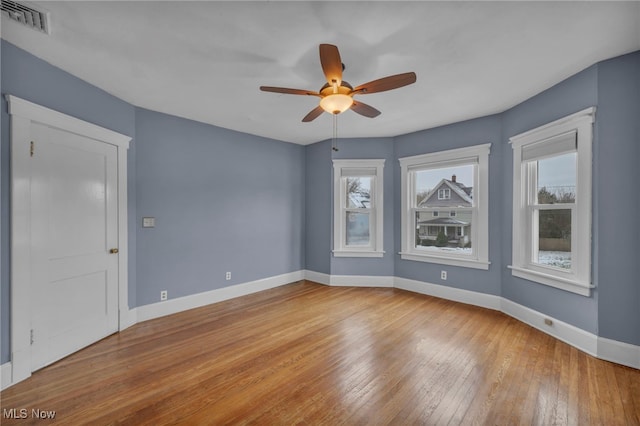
<box><xmin>394</xmin><ymin>277</ymin><xmax>502</xmax><ymax>311</ymax></box>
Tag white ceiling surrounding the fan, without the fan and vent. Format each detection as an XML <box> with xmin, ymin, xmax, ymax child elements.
<box><xmin>1</xmin><ymin>1</ymin><xmax>640</xmax><ymax>144</ymax></box>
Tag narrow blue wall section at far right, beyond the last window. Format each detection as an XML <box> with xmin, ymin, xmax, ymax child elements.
<box><xmin>594</xmin><ymin>52</ymin><xmax>640</xmax><ymax>345</ymax></box>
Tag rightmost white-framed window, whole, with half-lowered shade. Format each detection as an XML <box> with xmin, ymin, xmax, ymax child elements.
<box><xmin>510</xmin><ymin>108</ymin><xmax>595</xmax><ymax>296</ymax></box>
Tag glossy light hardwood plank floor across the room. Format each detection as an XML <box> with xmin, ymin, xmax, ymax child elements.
<box><xmin>0</xmin><ymin>281</ymin><xmax>640</xmax><ymax>425</ymax></box>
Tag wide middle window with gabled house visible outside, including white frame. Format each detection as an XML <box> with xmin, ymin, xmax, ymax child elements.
<box><xmin>400</xmin><ymin>144</ymin><xmax>491</xmax><ymax>269</ymax></box>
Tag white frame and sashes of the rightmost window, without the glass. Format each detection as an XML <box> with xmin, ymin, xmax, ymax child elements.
<box><xmin>509</xmin><ymin>107</ymin><xmax>596</xmax><ymax>296</ymax></box>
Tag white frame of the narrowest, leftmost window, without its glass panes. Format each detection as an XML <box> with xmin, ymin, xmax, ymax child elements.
<box><xmin>332</xmin><ymin>159</ymin><xmax>385</xmax><ymax>257</ymax></box>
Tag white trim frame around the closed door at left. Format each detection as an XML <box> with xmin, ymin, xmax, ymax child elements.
<box><xmin>5</xmin><ymin>95</ymin><xmax>131</xmax><ymax>384</ymax></box>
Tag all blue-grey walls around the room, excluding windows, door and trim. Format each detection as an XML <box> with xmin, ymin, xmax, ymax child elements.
<box><xmin>0</xmin><ymin>41</ymin><xmax>640</xmax><ymax>363</ymax></box>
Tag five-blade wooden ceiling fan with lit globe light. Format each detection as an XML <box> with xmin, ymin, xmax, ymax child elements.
<box><xmin>260</xmin><ymin>44</ymin><xmax>416</xmax><ymax>123</ymax></box>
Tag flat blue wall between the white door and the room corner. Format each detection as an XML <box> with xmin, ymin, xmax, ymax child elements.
<box><xmin>136</xmin><ymin>109</ymin><xmax>305</xmax><ymax>306</ymax></box>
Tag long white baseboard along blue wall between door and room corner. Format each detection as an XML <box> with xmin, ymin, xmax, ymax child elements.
<box><xmin>135</xmin><ymin>271</ymin><xmax>304</xmax><ymax>322</ymax></box>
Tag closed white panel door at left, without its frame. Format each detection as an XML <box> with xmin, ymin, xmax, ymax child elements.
<box><xmin>30</xmin><ymin>122</ymin><xmax>119</xmax><ymax>370</ymax></box>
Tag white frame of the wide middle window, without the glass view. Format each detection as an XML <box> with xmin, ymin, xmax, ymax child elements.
<box><xmin>399</xmin><ymin>143</ymin><xmax>491</xmax><ymax>270</ymax></box>
